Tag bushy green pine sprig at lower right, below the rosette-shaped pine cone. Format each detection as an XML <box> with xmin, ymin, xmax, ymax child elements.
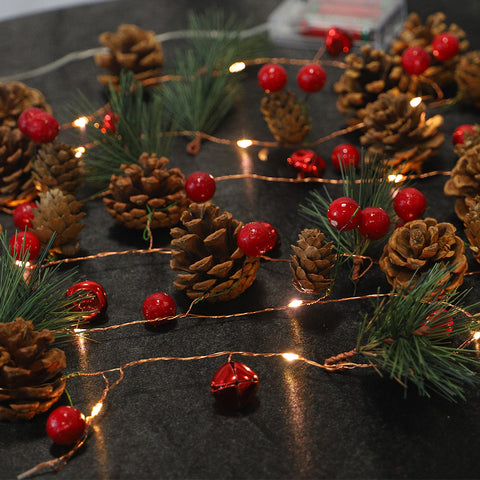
<box><xmin>356</xmin><ymin>264</ymin><xmax>480</xmax><ymax>401</ymax></box>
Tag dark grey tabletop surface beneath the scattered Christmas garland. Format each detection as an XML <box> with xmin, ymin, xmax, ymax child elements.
<box><xmin>0</xmin><ymin>0</ymin><xmax>480</xmax><ymax>479</ymax></box>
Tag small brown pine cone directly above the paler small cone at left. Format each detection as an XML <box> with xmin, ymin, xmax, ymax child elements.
<box><xmin>32</xmin><ymin>143</ymin><xmax>83</xmax><ymax>195</ymax></box>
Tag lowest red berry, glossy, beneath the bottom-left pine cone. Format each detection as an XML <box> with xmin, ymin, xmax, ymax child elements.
<box><xmin>47</xmin><ymin>407</ymin><xmax>86</xmax><ymax>445</ymax></box>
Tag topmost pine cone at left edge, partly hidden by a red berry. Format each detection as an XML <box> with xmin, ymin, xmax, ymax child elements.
<box><xmin>0</xmin><ymin>82</ymin><xmax>52</xmax><ymax>127</ymax></box>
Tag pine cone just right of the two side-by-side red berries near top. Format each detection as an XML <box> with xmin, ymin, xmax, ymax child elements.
<box><xmin>333</xmin><ymin>45</ymin><xmax>417</xmax><ymax>125</ymax></box>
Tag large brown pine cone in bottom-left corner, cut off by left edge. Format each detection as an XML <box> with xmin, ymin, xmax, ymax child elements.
<box><xmin>0</xmin><ymin>318</ymin><xmax>66</xmax><ymax>420</ymax></box>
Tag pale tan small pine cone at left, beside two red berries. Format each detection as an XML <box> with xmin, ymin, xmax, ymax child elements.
<box><xmin>32</xmin><ymin>188</ymin><xmax>85</xmax><ymax>257</ymax></box>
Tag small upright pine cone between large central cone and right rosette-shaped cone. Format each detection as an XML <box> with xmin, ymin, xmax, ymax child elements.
<box><xmin>290</xmin><ymin>228</ymin><xmax>337</xmax><ymax>294</ymax></box>
